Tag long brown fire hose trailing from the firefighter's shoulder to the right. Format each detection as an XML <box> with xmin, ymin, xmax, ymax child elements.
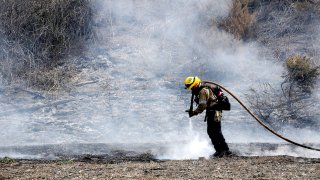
<box><xmin>206</xmin><ymin>81</ymin><xmax>320</xmax><ymax>151</ymax></box>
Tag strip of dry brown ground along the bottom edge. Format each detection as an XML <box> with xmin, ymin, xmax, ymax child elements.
<box><xmin>0</xmin><ymin>154</ymin><xmax>320</xmax><ymax>179</ymax></box>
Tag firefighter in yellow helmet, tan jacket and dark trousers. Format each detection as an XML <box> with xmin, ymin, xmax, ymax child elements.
<box><xmin>185</xmin><ymin>76</ymin><xmax>231</xmax><ymax>157</ymax></box>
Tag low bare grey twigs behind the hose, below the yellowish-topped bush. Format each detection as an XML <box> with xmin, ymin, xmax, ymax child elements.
<box><xmin>247</xmin><ymin>84</ymin><xmax>318</xmax><ymax>131</ymax></box>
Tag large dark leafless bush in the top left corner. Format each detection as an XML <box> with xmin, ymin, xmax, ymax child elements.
<box><xmin>0</xmin><ymin>0</ymin><xmax>93</xmax><ymax>89</ymax></box>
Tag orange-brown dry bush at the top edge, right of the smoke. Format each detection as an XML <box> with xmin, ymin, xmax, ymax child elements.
<box><xmin>219</xmin><ymin>0</ymin><xmax>255</xmax><ymax>39</ymax></box>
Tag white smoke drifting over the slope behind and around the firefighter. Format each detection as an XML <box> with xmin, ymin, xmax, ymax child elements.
<box><xmin>0</xmin><ymin>0</ymin><xmax>318</xmax><ymax>159</ymax></box>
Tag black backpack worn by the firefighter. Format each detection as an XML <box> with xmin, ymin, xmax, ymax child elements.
<box><xmin>201</xmin><ymin>83</ymin><xmax>231</xmax><ymax>111</ymax></box>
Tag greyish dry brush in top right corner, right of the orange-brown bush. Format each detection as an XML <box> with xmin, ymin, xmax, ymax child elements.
<box><xmin>250</xmin><ymin>0</ymin><xmax>320</xmax><ymax>61</ymax></box>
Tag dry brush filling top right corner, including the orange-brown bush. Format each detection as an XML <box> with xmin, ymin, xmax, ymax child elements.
<box><xmin>219</xmin><ymin>0</ymin><xmax>320</xmax><ymax>58</ymax></box>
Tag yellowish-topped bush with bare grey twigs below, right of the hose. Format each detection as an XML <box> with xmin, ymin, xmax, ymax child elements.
<box><xmin>247</xmin><ymin>55</ymin><xmax>319</xmax><ymax>130</ymax></box>
